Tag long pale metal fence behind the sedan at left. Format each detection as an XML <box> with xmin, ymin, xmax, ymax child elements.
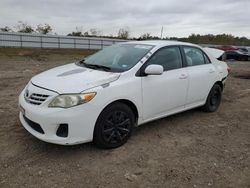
<box><xmin>0</xmin><ymin>32</ymin><xmax>128</xmax><ymax>50</ymax></box>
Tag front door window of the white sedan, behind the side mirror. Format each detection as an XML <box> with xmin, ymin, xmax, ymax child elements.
<box><xmin>148</xmin><ymin>47</ymin><xmax>182</xmax><ymax>71</ymax></box>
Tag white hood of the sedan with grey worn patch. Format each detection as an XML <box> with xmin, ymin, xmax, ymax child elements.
<box><xmin>31</xmin><ymin>63</ymin><xmax>120</xmax><ymax>94</ymax></box>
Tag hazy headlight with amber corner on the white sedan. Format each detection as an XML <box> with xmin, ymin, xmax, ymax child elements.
<box><xmin>49</xmin><ymin>92</ymin><xmax>96</xmax><ymax>108</ymax></box>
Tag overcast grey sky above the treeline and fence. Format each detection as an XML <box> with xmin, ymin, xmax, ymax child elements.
<box><xmin>0</xmin><ymin>0</ymin><xmax>250</xmax><ymax>38</ymax></box>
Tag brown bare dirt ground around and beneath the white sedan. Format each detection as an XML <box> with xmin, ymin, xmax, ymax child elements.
<box><xmin>0</xmin><ymin>49</ymin><xmax>250</xmax><ymax>188</ymax></box>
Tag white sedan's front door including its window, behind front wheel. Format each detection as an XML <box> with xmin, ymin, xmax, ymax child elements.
<box><xmin>142</xmin><ymin>46</ymin><xmax>188</xmax><ymax>120</ymax></box>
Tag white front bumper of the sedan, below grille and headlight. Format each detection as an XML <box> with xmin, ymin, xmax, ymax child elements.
<box><xmin>19</xmin><ymin>85</ymin><xmax>99</xmax><ymax>145</ymax></box>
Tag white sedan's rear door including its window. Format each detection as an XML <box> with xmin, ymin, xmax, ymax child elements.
<box><xmin>183</xmin><ymin>46</ymin><xmax>216</xmax><ymax>107</ymax></box>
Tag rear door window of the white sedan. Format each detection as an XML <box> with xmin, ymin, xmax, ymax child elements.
<box><xmin>183</xmin><ymin>47</ymin><xmax>206</xmax><ymax>67</ymax></box>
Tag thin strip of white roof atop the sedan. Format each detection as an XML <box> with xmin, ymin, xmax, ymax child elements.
<box><xmin>126</xmin><ymin>40</ymin><xmax>200</xmax><ymax>48</ymax></box>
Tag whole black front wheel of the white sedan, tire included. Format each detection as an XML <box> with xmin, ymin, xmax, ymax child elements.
<box><xmin>93</xmin><ymin>102</ymin><xmax>135</xmax><ymax>149</ymax></box>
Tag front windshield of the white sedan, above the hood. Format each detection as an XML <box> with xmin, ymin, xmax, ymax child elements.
<box><xmin>78</xmin><ymin>44</ymin><xmax>154</xmax><ymax>72</ymax></box>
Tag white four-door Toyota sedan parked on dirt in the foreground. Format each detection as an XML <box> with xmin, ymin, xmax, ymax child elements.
<box><xmin>19</xmin><ymin>41</ymin><xmax>228</xmax><ymax>148</ymax></box>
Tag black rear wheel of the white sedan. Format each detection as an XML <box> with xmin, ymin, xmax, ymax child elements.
<box><xmin>203</xmin><ymin>84</ymin><xmax>222</xmax><ymax>112</ymax></box>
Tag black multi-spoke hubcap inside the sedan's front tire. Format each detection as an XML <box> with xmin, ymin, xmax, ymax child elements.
<box><xmin>103</xmin><ymin>111</ymin><xmax>131</xmax><ymax>144</ymax></box>
